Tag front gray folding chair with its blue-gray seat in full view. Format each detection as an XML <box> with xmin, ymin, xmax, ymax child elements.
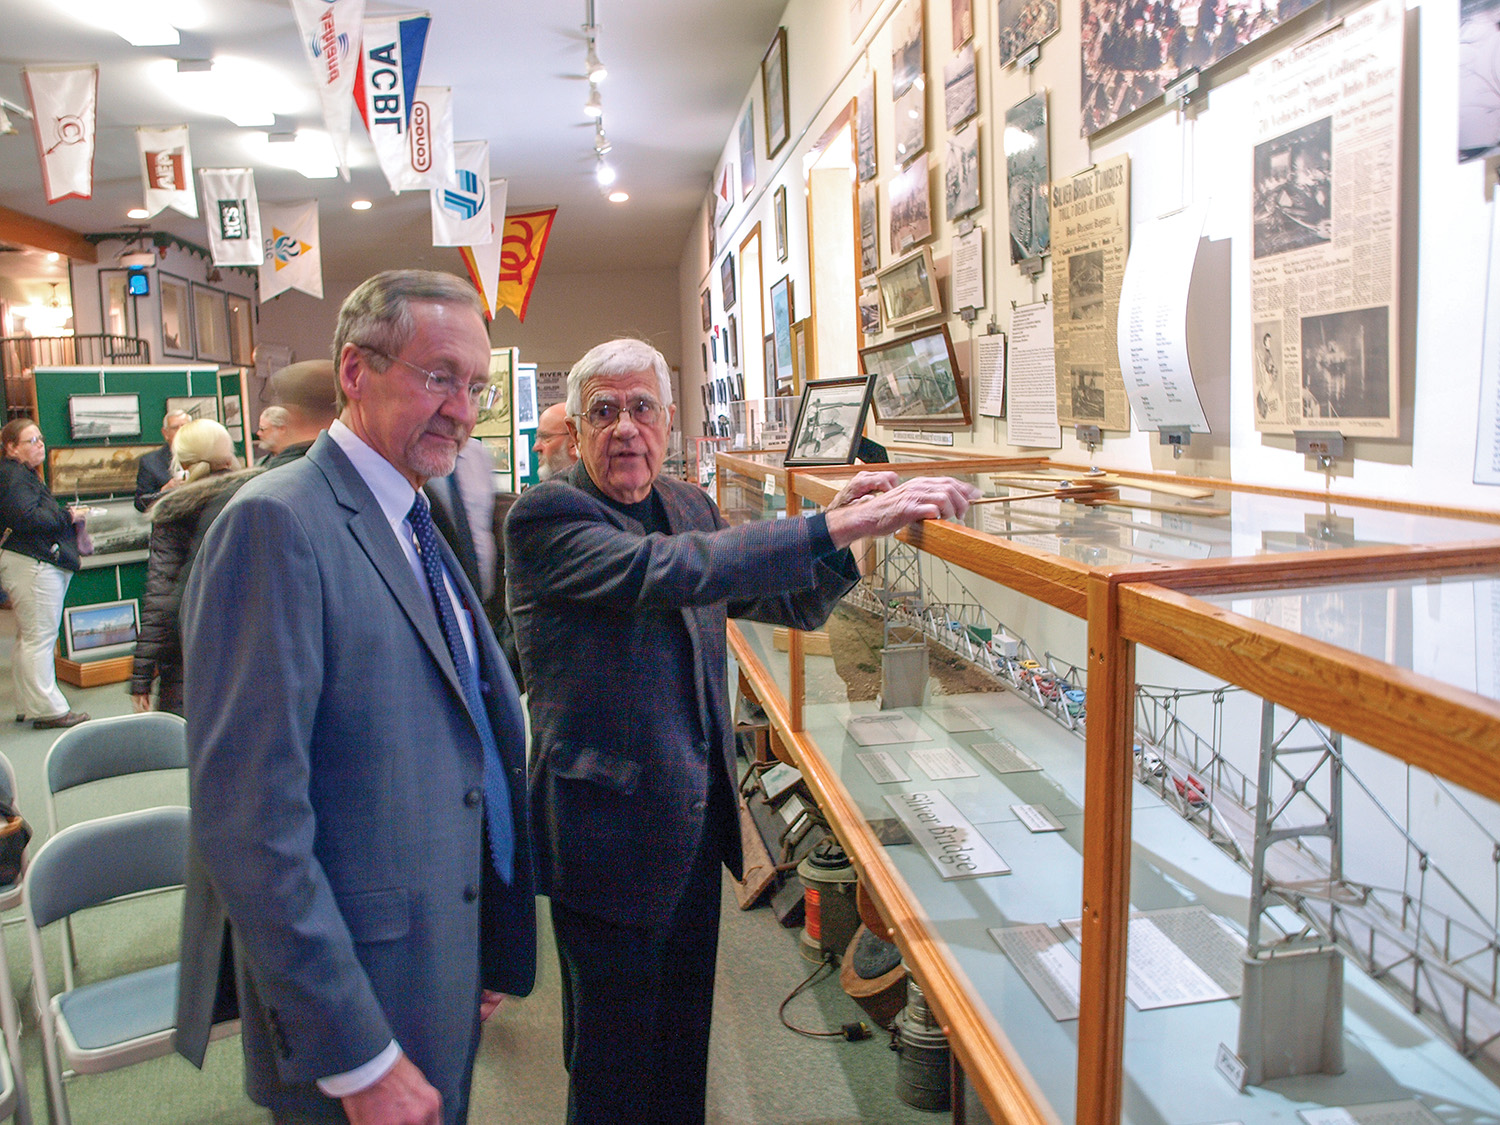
<box><xmin>24</xmin><ymin>806</ymin><xmax>229</xmax><ymax>1125</ymax></box>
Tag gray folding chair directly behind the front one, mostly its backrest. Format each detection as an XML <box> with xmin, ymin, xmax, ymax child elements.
<box><xmin>45</xmin><ymin>711</ymin><xmax>188</xmax><ymax>989</ymax></box>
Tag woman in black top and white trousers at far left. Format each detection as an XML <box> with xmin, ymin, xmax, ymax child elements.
<box><xmin>0</xmin><ymin>419</ymin><xmax>89</xmax><ymax>729</ymax></box>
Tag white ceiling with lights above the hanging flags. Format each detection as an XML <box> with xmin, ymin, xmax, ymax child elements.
<box><xmin>0</xmin><ymin>0</ymin><xmax>785</xmax><ymax>291</ymax></box>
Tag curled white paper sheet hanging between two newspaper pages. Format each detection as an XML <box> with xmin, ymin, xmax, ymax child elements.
<box><xmin>1116</xmin><ymin>207</ymin><xmax>1209</xmax><ymax>434</ymax></box>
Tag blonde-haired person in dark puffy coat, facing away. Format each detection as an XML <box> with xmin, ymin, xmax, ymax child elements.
<box><xmin>131</xmin><ymin>419</ymin><xmax>257</xmax><ymax>716</ymax></box>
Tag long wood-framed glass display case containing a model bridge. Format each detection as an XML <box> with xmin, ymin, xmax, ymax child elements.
<box><xmin>719</xmin><ymin>455</ymin><xmax>1500</xmax><ymax>1125</ymax></box>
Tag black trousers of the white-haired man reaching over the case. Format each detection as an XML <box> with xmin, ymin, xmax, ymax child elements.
<box><xmin>552</xmin><ymin>818</ymin><xmax>723</xmax><ymax>1125</ymax></box>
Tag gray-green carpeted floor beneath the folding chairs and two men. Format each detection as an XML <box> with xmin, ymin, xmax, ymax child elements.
<box><xmin>0</xmin><ymin>611</ymin><xmax>951</xmax><ymax>1125</ymax></box>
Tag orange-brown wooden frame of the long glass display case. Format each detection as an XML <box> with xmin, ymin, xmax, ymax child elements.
<box><xmin>720</xmin><ymin>455</ymin><xmax>1500</xmax><ymax>1125</ymax></box>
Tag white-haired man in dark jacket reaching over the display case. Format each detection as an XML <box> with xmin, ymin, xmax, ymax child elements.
<box><xmin>506</xmin><ymin>341</ymin><xmax>978</xmax><ymax>1125</ymax></box>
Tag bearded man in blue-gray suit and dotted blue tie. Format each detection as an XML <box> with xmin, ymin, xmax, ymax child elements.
<box><xmin>180</xmin><ymin>272</ymin><xmax>536</xmax><ymax>1125</ymax></box>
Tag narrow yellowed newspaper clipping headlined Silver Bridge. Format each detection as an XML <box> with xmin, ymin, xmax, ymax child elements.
<box><xmin>1052</xmin><ymin>156</ymin><xmax>1130</xmax><ymax>431</ymax></box>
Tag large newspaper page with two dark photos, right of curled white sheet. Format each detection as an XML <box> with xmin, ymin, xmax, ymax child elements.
<box><xmin>1250</xmin><ymin>0</ymin><xmax>1406</xmax><ymax>438</ymax></box>
